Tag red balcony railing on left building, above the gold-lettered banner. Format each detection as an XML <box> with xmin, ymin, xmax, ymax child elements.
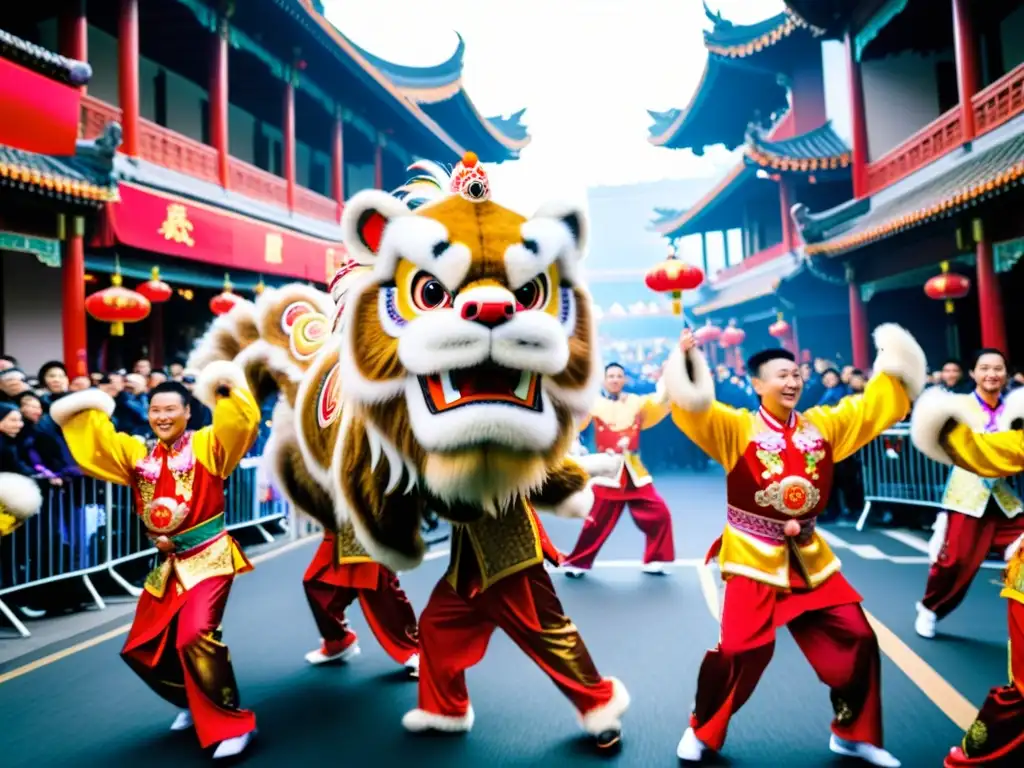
<box><xmin>81</xmin><ymin>95</ymin><xmax>338</xmax><ymax>222</ymax></box>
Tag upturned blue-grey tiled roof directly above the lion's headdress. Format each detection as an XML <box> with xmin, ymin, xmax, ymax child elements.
<box><xmin>325</xmin><ymin>24</ymin><xmax>530</xmax><ymax>163</ymax></box>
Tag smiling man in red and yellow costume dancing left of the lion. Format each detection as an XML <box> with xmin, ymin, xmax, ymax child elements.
<box><xmin>50</xmin><ymin>370</ymin><xmax>260</xmax><ymax>758</ymax></box>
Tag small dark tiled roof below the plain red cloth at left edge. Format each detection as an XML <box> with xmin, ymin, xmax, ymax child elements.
<box><xmin>0</xmin><ymin>126</ymin><xmax>121</xmax><ymax>208</ymax></box>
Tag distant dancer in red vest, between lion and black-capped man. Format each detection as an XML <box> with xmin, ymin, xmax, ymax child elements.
<box><xmin>562</xmin><ymin>362</ymin><xmax>676</xmax><ymax>578</ymax></box>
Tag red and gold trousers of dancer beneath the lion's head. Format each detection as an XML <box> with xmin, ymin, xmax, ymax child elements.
<box><xmin>419</xmin><ymin>565</ymin><xmax>613</xmax><ymax>717</ymax></box>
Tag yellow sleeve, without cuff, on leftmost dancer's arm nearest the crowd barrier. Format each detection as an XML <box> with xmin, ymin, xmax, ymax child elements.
<box><xmin>61</xmin><ymin>409</ymin><xmax>148</xmax><ymax>485</ymax></box>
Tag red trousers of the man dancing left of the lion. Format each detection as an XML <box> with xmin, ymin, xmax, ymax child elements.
<box><xmin>121</xmin><ymin>577</ymin><xmax>256</xmax><ymax>749</ymax></box>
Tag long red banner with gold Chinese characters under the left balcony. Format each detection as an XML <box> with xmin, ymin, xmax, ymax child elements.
<box><xmin>110</xmin><ymin>182</ymin><xmax>344</xmax><ymax>283</ymax></box>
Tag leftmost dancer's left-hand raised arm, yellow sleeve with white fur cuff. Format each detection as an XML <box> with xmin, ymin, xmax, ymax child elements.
<box><xmin>50</xmin><ymin>389</ymin><xmax>146</xmax><ymax>485</ymax></box>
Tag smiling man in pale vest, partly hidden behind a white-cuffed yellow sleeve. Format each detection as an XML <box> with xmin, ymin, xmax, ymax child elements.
<box><xmin>913</xmin><ymin>349</ymin><xmax>1024</xmax><ymax>638</ymax></box>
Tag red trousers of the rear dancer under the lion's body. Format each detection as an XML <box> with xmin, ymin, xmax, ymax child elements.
<box><xmin>302</xmin><ymin>560</ymin><xmax>419</xmax><ymax>664</ymax></box>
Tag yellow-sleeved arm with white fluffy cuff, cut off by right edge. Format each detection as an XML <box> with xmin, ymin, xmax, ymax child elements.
<box><xmin>910</xmin><ymin>389</ymin><xmax>1024</xmax><ymax>477</ymax></box>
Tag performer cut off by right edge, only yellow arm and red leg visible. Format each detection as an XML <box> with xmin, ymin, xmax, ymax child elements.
<box><xmin>910</xmin><ymin>389</ymin><xmax>1024</xmax><ymax>768</ymax></box>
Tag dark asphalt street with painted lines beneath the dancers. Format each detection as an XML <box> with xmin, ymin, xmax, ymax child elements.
<box><xmin>0</xmin><ymin>474</ymin><xmax>1007</xmax><ymax>768</ymax></box>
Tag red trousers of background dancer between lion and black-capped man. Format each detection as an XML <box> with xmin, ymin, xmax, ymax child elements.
<box><xmin>562</xmin><ymin>478</ymin><xmax>676</xmax><ymax>568</ymax></box>
